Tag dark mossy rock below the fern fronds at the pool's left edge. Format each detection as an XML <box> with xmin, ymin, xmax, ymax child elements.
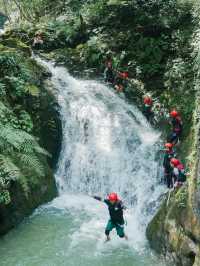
<box><xmin>0</xmin><ymin>166</ymin><xmax>57</xmax><ymax>235</ymax></box>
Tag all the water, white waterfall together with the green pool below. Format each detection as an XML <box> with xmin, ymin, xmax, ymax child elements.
<box><xmin>0</xmin><ymin>59</ymin><xmax>171</xmax><ymax>266</ymax></box>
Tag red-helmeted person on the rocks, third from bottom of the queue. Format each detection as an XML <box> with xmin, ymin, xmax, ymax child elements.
<box><xmin>168</xmin><ymin>109</ymin><xmax>183</xmax><ymax>144</ymax></box>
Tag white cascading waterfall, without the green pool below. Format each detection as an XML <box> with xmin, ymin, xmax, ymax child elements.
<box><xmin>38</xmin><ymin>58</ymin><xmax>164</xmax><ymax>247</ymax></box>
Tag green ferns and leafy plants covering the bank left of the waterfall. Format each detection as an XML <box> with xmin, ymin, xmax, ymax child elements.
<box><xmin>0</xmin><ymin>42</ymin><xmax>53</xmax><ymax>204</ymax></box>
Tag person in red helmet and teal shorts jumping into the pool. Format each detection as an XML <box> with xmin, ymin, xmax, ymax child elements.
<box><xmin>93</xmin><ymin>193</ymin><xmax>128</xmax><ymax>241</ymax></box>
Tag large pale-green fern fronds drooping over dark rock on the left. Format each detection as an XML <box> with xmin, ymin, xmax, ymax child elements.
<box><xmin>0</xmin><ymin>121</ymin><xmax>50</xmax><ymax>201</ymax></box>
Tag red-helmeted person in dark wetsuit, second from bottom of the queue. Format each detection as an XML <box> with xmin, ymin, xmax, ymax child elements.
<box><xmin>163</xmin><ymin>143</ymin><xmax>175</xmax><ymax>188</ymax></box>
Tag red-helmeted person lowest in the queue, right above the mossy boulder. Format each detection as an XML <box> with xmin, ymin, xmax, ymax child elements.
<box><xmin>170</xmin><ymin>158</ymin><xmax>186</xmax><ymax>188</ymax></box>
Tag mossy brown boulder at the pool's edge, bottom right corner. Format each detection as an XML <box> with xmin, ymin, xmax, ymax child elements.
<box><xmin>146</xmin><ymin>178</ymin><xmax>200</xmax><ymax>266</ymax></box>
